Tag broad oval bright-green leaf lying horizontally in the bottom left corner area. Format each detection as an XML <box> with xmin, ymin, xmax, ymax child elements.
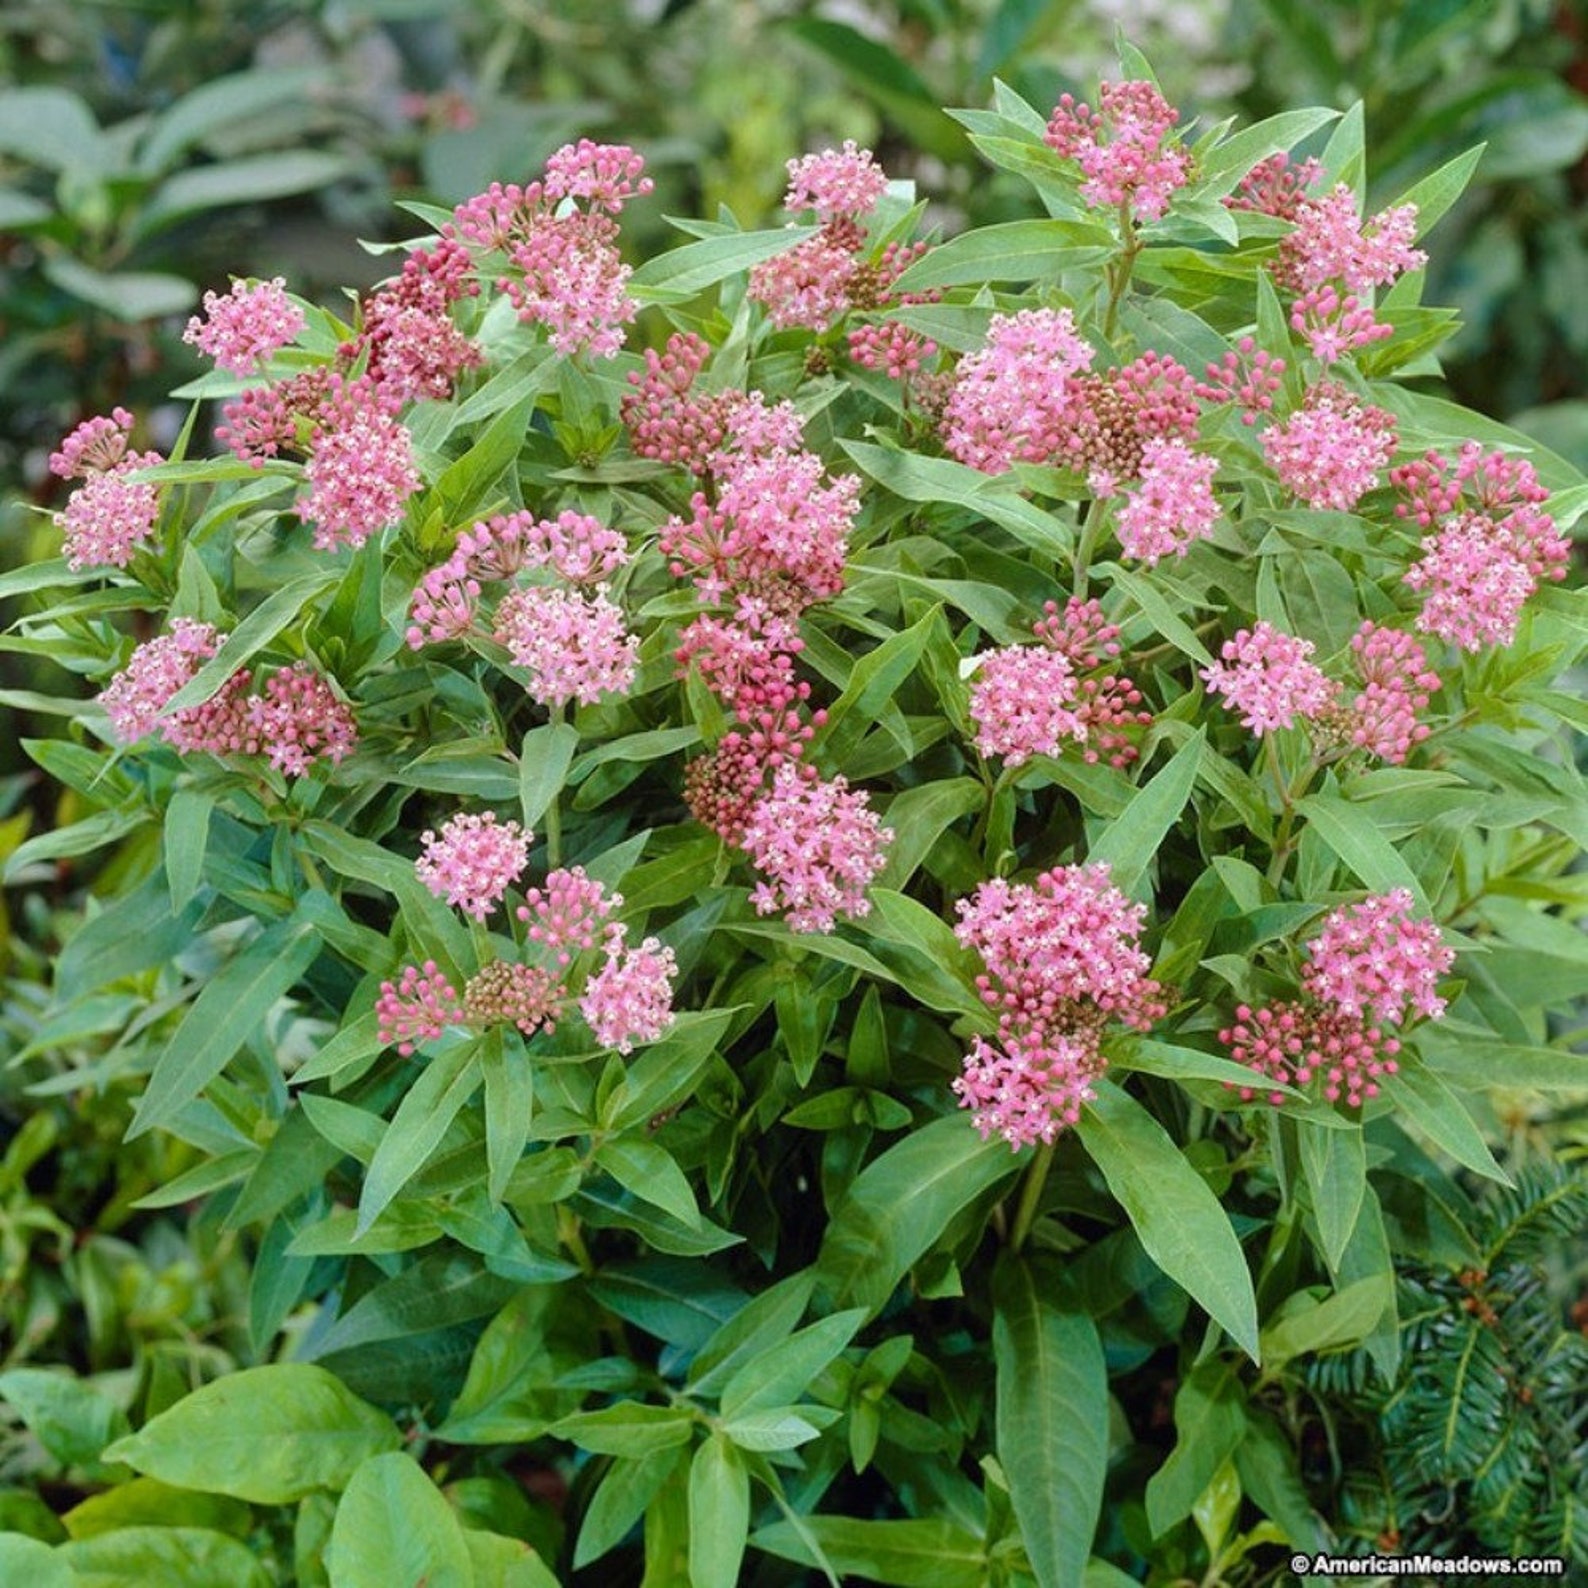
<box><xmin>106</xmin><ymin>1363</ymin><xmax>400</xmax><ymax>1505</ymax></box>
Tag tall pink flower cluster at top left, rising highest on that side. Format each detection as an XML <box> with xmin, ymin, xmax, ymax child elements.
<box><xmin>446</xmin><ymin>138</ymin><xmax>653</xmax><ymax>357</ymax></box>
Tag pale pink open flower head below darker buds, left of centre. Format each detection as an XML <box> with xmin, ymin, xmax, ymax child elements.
<box><xmin>495</xmin><ymin>584</ymin><xmax>640</xmax><ymax>707</ymax></box>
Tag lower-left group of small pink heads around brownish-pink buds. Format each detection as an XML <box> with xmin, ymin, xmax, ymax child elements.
<box><xmin>385</xmin><ymin>844</ymin><xmax>678</xmax><ymax>1054</ymax></box>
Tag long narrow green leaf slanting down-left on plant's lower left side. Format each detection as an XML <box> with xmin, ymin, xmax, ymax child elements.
<box><xmin>127</xmin><ymin>915</ymin><xmax>321</xmax><ymax>1140</ymax></box>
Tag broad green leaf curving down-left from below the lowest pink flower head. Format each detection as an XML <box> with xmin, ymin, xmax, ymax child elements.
<box><xmin>816</xmin><ymin>1115</ymin><xmax>1022</xmax><ymax>1308</ymax></box>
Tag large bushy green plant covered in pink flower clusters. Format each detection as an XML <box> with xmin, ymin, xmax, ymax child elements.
<box><xmin>8</xmin><ymin>54</ymin><xmax>1588</xmax><ymax>1588</ymax></box>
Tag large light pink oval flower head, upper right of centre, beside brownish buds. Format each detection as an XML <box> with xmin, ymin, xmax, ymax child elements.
<box><xmin>943</xmin><ymin>308</ymin><xmax>1096</xmax><ymax>475</ymax></box>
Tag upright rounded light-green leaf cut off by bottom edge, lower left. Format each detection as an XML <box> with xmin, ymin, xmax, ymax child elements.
<box><xmin>326</xmin><ymin>1450</ymin><xmax>475</xmax><ymax>1588</ymax></box>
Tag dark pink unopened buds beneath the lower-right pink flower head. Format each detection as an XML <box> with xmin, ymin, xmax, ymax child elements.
<box><xmin>1218</xmin><ymin>1000</ymin><xmax>1401</xmax><ymax>1108</ymax></box>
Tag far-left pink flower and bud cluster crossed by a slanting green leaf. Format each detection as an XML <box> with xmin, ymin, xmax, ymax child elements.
<box><xmin>100</xmin><ymin>632</ymin><xmax>359</xmax><ymax>777</ymax></box>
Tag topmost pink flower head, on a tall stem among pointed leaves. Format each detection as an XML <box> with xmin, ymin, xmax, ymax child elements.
<box><xmin>1043</xmin><ymin>79</ymin><xmax>1191</xmax><ymax>221</ymax></box>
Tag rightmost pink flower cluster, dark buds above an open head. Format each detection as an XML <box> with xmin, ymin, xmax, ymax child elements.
<box><xmin>1390</xmin><ymin>441</ymin><xmax>1571</xmax><ymax>651</ymax></box>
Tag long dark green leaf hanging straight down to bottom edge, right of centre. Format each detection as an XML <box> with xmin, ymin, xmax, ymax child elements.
<box><xmin>993</xmin><ymin>1258</ymin><xmax>1108</xmax><ymax>1588</ymax></box>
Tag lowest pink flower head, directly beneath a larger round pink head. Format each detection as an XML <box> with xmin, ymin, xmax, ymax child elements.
<box><xmin>953</xmin><ymin>1031</ymin><xmax>1107</xmax><ymax>1151</ymax></box>
